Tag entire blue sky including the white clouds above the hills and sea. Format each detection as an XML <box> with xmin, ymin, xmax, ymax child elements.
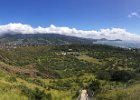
<box><xmin>0</xmin><ymin>0</ymin><xmax>140</xmax><ymax>39</ymax></box>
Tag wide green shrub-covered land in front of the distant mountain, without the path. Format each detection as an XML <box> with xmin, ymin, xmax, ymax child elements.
<box><xmin>0</xmin><ymin>44</ymin><xmax>140</xmax><ymax>100</ymax></box>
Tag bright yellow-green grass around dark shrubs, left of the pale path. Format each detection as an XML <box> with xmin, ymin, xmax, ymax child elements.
<box><xmin>0</xmin><ymin>71</ymin><xmax>79</xmax><ymax>100</ymax></box>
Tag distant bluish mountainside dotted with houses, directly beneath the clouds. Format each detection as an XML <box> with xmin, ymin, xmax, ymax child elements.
<box><xmin>0</xmin><ymin>33</ymin><xmax>93</xmax><ymax>47</ymax></box>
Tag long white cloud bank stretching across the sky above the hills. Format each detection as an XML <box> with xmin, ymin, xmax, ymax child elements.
<box><xmin>0</xmin><ymin>23</ymin><xmax>140</xmax><ymax>41</ymax></box>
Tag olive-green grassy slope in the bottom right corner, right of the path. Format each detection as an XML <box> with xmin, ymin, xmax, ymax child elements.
<box><xmin>97</xmin><ymin>83</ymin><xmax>140</xmax><ymax>100</ymax></box>
